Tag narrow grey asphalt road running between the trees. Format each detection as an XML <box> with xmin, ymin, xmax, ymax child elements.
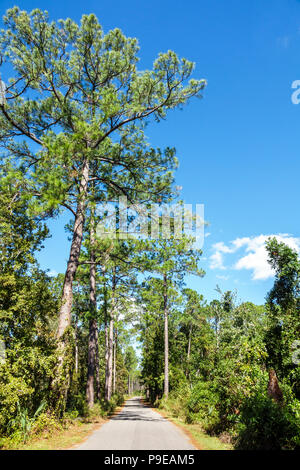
<box><xmin>76</xmin><ymin>397</ymin><xmax>196</xmax><ymax>450</ymax></box>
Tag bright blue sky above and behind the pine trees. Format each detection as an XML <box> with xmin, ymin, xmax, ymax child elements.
<box><xmin>0</xmin><ymin>0</ymin><xmax>300</xmax><ymax>303</ymax></box>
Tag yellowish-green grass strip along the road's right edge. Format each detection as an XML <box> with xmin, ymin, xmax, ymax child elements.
<box><xmin>142</xmin><ymin>400</ymin><xmax>233</xmax><ymax>450</ymax></box>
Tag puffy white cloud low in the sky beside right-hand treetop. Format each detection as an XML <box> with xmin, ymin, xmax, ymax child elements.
<box><xmin>210</xmin><ymin>233</ymin><xmax>300</xmax><ymax>280</ymax></box>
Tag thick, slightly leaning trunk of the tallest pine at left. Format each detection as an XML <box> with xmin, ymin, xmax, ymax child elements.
<box><xmin>51</xmin><ymin>160</ymin><xmax>89</xmax><ymax>413</ymax></box>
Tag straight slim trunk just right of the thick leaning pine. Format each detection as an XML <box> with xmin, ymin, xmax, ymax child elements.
<box><xmin>86</xmin><ymin>209</ymin><xmax>98</xmax><ymax>408</ymax></box>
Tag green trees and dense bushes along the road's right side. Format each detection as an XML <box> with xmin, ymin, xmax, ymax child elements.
<box><xmin>142</xmin><ymin>239</ymin><xmax>300</xmax><ymax>450</ymax></box>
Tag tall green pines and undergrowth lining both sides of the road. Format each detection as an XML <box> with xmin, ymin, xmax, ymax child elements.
<box><xmin>0</xmin><ymin>7</ymin><xmax>300</xmax><ymax>449</ymax></box>
